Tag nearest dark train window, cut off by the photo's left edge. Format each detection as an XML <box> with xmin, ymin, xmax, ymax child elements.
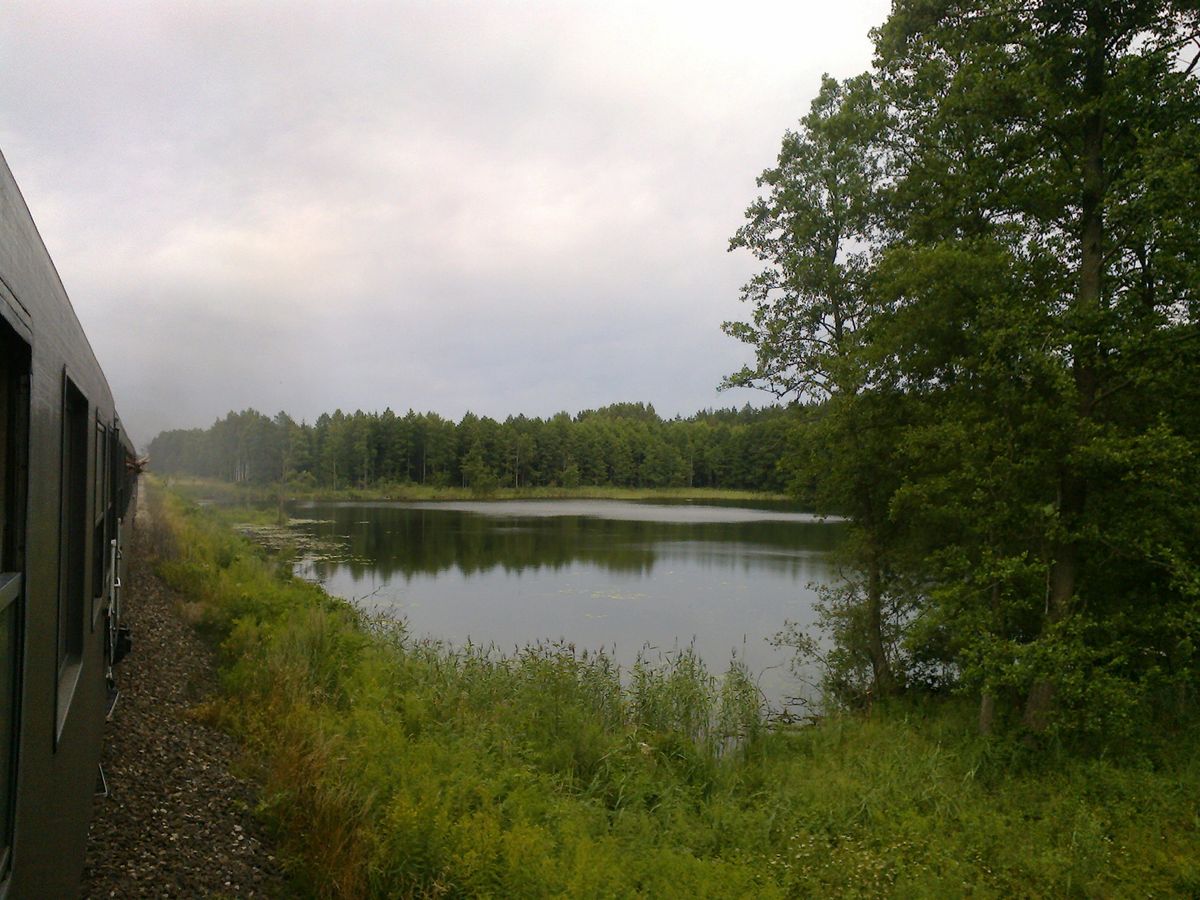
<box><xmin>0</xmin><ymin>319</ymin><xmax>30</xmax><ymax>880</ymax></box>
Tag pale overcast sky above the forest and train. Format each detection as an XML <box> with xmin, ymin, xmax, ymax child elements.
<box><xmin>0</xmin><ymin>0</ymin><xmax>889</xmax><ymax>444</ymax></box>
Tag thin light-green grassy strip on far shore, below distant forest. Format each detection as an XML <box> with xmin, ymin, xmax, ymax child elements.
<box><xmin>162</xmin><ymin>478</ymin><xmax>788</xmax><ymax>511</ymax></box>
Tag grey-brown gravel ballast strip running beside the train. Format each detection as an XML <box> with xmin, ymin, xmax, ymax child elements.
<box><xmin>82</xmin><ymin>504</ymin><xmax>288</xmax><ymax>898</ymax></box>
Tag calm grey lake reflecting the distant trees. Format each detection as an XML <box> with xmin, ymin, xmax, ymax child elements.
<box><xmin>288</xmin><ymin>500</ymin><xmax>842</xmax><ymax>708</ymax></box>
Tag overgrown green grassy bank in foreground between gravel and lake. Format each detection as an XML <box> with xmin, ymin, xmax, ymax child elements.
<box><xmin>150</xmin><ymin>480</ymin><xmax>1200</xmax><ymax>898</ymax></box>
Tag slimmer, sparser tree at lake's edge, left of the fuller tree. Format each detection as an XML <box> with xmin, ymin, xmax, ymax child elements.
<box><xmin>725</xmin><ymin>76</ymin><xmax>904</xmax><ymax>694</ymax></box>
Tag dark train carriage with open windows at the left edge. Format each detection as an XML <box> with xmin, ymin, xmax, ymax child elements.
<box><xmin>0</xmin><ymin>155</ymin><xmax>136</xmax><ymax>900</ymax></box>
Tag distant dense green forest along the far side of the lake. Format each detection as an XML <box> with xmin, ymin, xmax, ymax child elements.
<box><xmin>148</xmin><ymin>403</ymin><xmax>799</xmax><ymax>493</ymax></box>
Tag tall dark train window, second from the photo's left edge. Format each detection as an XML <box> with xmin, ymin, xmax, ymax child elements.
<box><xmin>56</xmin><ymin>378</ymin><xmax>89</xmax><ymax>733</ymax></box>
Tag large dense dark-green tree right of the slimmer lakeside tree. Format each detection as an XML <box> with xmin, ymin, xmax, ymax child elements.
<box><xmin>877</xmin><ymin>0</ymin><xmax>1200</xmax><ymax>732</ymax></box>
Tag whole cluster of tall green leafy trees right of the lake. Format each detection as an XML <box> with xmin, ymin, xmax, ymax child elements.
<box><xmin>725</xmin><ymin>0</ymin><xmax>1200</xmax><ymax>744</ymax></box>
